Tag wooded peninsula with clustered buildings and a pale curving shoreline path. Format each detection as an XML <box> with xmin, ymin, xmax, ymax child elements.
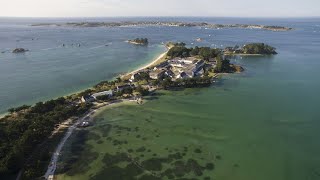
<box><xmin>0</xmin><ymin>43</ymin><xmax>274</xmax><ymax>179</ymax></box>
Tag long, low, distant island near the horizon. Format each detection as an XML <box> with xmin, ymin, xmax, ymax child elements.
<box><xmin>31</xmin><ymin>21</ymin><xmax>293</xmax><ymax>31</ymax></box>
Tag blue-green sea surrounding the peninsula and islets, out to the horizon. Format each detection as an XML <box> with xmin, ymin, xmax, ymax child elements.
<box><xmin>0</xmin><ymin>17</ymin><xmax>320</xmax><ymax>180</ymax></box>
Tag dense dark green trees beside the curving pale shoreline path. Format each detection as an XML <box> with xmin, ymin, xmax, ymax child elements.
<box><xmin>0</xmin><ymin>97</ymin><xmax>91</xmax><ymax>179</ymax></box>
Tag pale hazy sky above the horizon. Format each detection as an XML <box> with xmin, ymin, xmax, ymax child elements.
<box><xmin>0</xmin><ymin>0</ymin><xmax>320</xmax><ymax>17</ymax></box>
